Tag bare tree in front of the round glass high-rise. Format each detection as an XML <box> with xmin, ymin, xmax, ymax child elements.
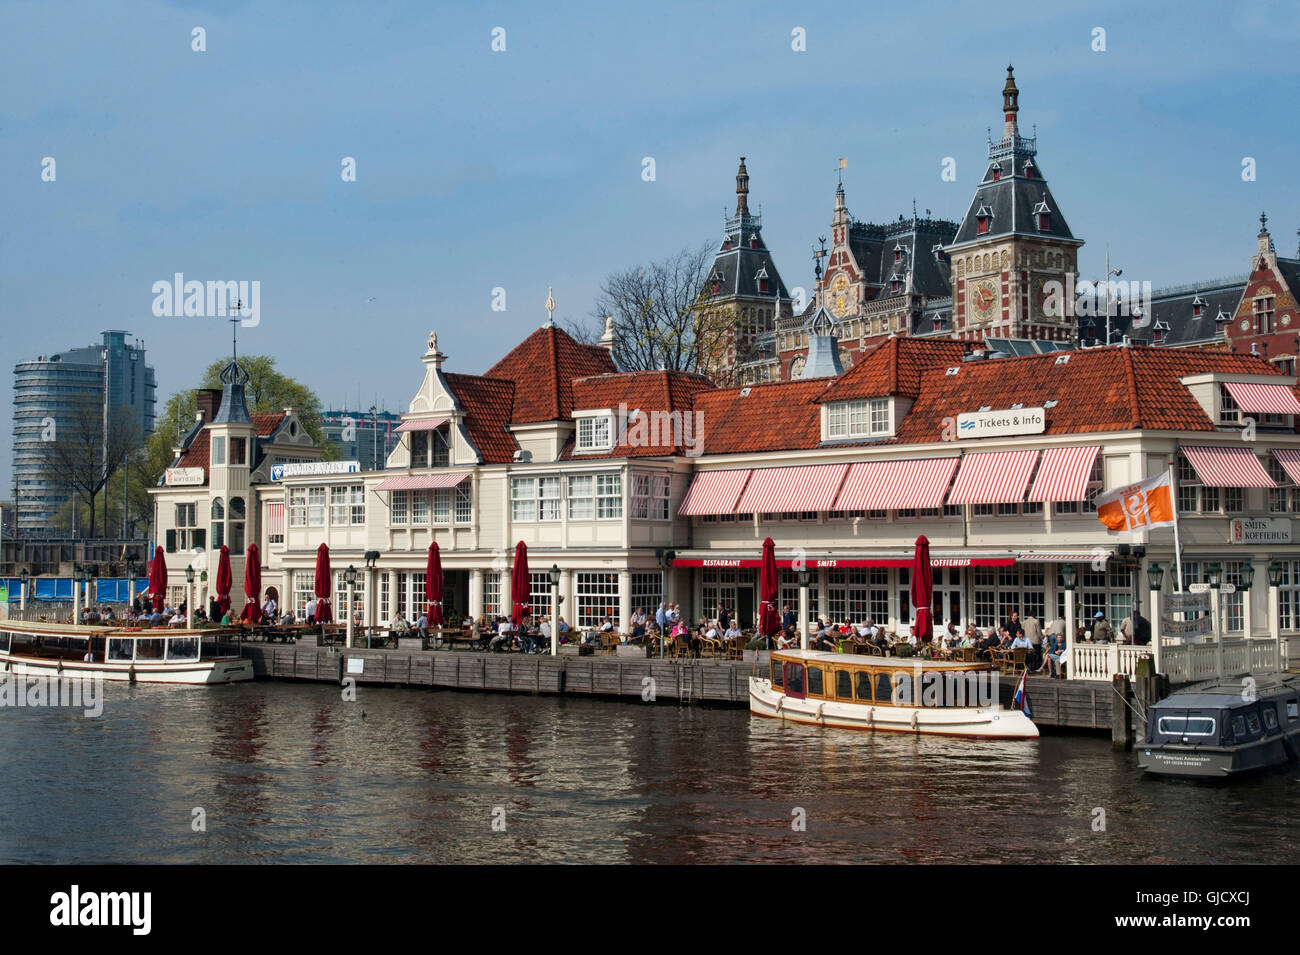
<box><xmin>40</xmin><ymin>399</ymin><xmax>143</xmax><ymax>538</ymax></box>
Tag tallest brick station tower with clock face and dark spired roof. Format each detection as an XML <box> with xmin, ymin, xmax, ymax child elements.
<box><xmin>944</xmin><ymin>66</ymin><xmax>1083</xmax><ymax>342</ymax></box>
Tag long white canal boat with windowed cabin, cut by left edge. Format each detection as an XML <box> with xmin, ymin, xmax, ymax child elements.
<box><xmin>0</xmin><ymin>620</ymin><xmax>254</xmax><ymax>685</ymax></box>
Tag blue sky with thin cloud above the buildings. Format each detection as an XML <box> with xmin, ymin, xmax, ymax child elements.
<box><xmin>0</xmin><ymin>0</ymin><xmax>1300</xmax><ymax>496</ymax></box>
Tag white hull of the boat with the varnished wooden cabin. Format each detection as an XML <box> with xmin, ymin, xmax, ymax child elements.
<box><xmin>749</xmin><ymin>677</ymin><xmax>1039</xmax><ymax>739</ymax></box>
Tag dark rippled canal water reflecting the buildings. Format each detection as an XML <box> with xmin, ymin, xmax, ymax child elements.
<box><xmin>0</xmin><ymin>683</ymin><xmax>1300</xmax><ymax>863</ymax></box>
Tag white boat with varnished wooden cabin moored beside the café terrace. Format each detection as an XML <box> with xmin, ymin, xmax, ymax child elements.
<box><xmin>749</xmin><ymin>650</ymin><xmax>1039</xmax><ymax>739</ymax></box>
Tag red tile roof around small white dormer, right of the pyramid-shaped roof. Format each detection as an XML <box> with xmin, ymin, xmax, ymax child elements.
<box><xmin>562</xmin><ymin>372</ymin><xmax>715</xmax><ymax>459</ymax></box>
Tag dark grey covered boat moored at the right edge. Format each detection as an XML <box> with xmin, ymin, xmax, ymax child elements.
<box><xmin>1138</xmin><ymin>674</ymin><xmax>1300</xmax><ymax>780</ymax></box>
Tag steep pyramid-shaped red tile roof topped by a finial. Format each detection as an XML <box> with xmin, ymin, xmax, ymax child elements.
<box><xmin>485</xmin><ymin>326</ymin><xmax>619</xmax><ymax>425</ymax></box>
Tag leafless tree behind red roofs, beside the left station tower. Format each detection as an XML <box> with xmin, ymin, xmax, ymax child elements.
<box><xmin>573</xmin><ymin>243</ymin><xmax>733</xmax><ymax>374</ymax></box>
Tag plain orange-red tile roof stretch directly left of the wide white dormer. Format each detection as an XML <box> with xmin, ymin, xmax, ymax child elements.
<box><xmin>696</xmin><ymin>378</ymin><xmax>833</xmax><ymax>455</ymax></box>
